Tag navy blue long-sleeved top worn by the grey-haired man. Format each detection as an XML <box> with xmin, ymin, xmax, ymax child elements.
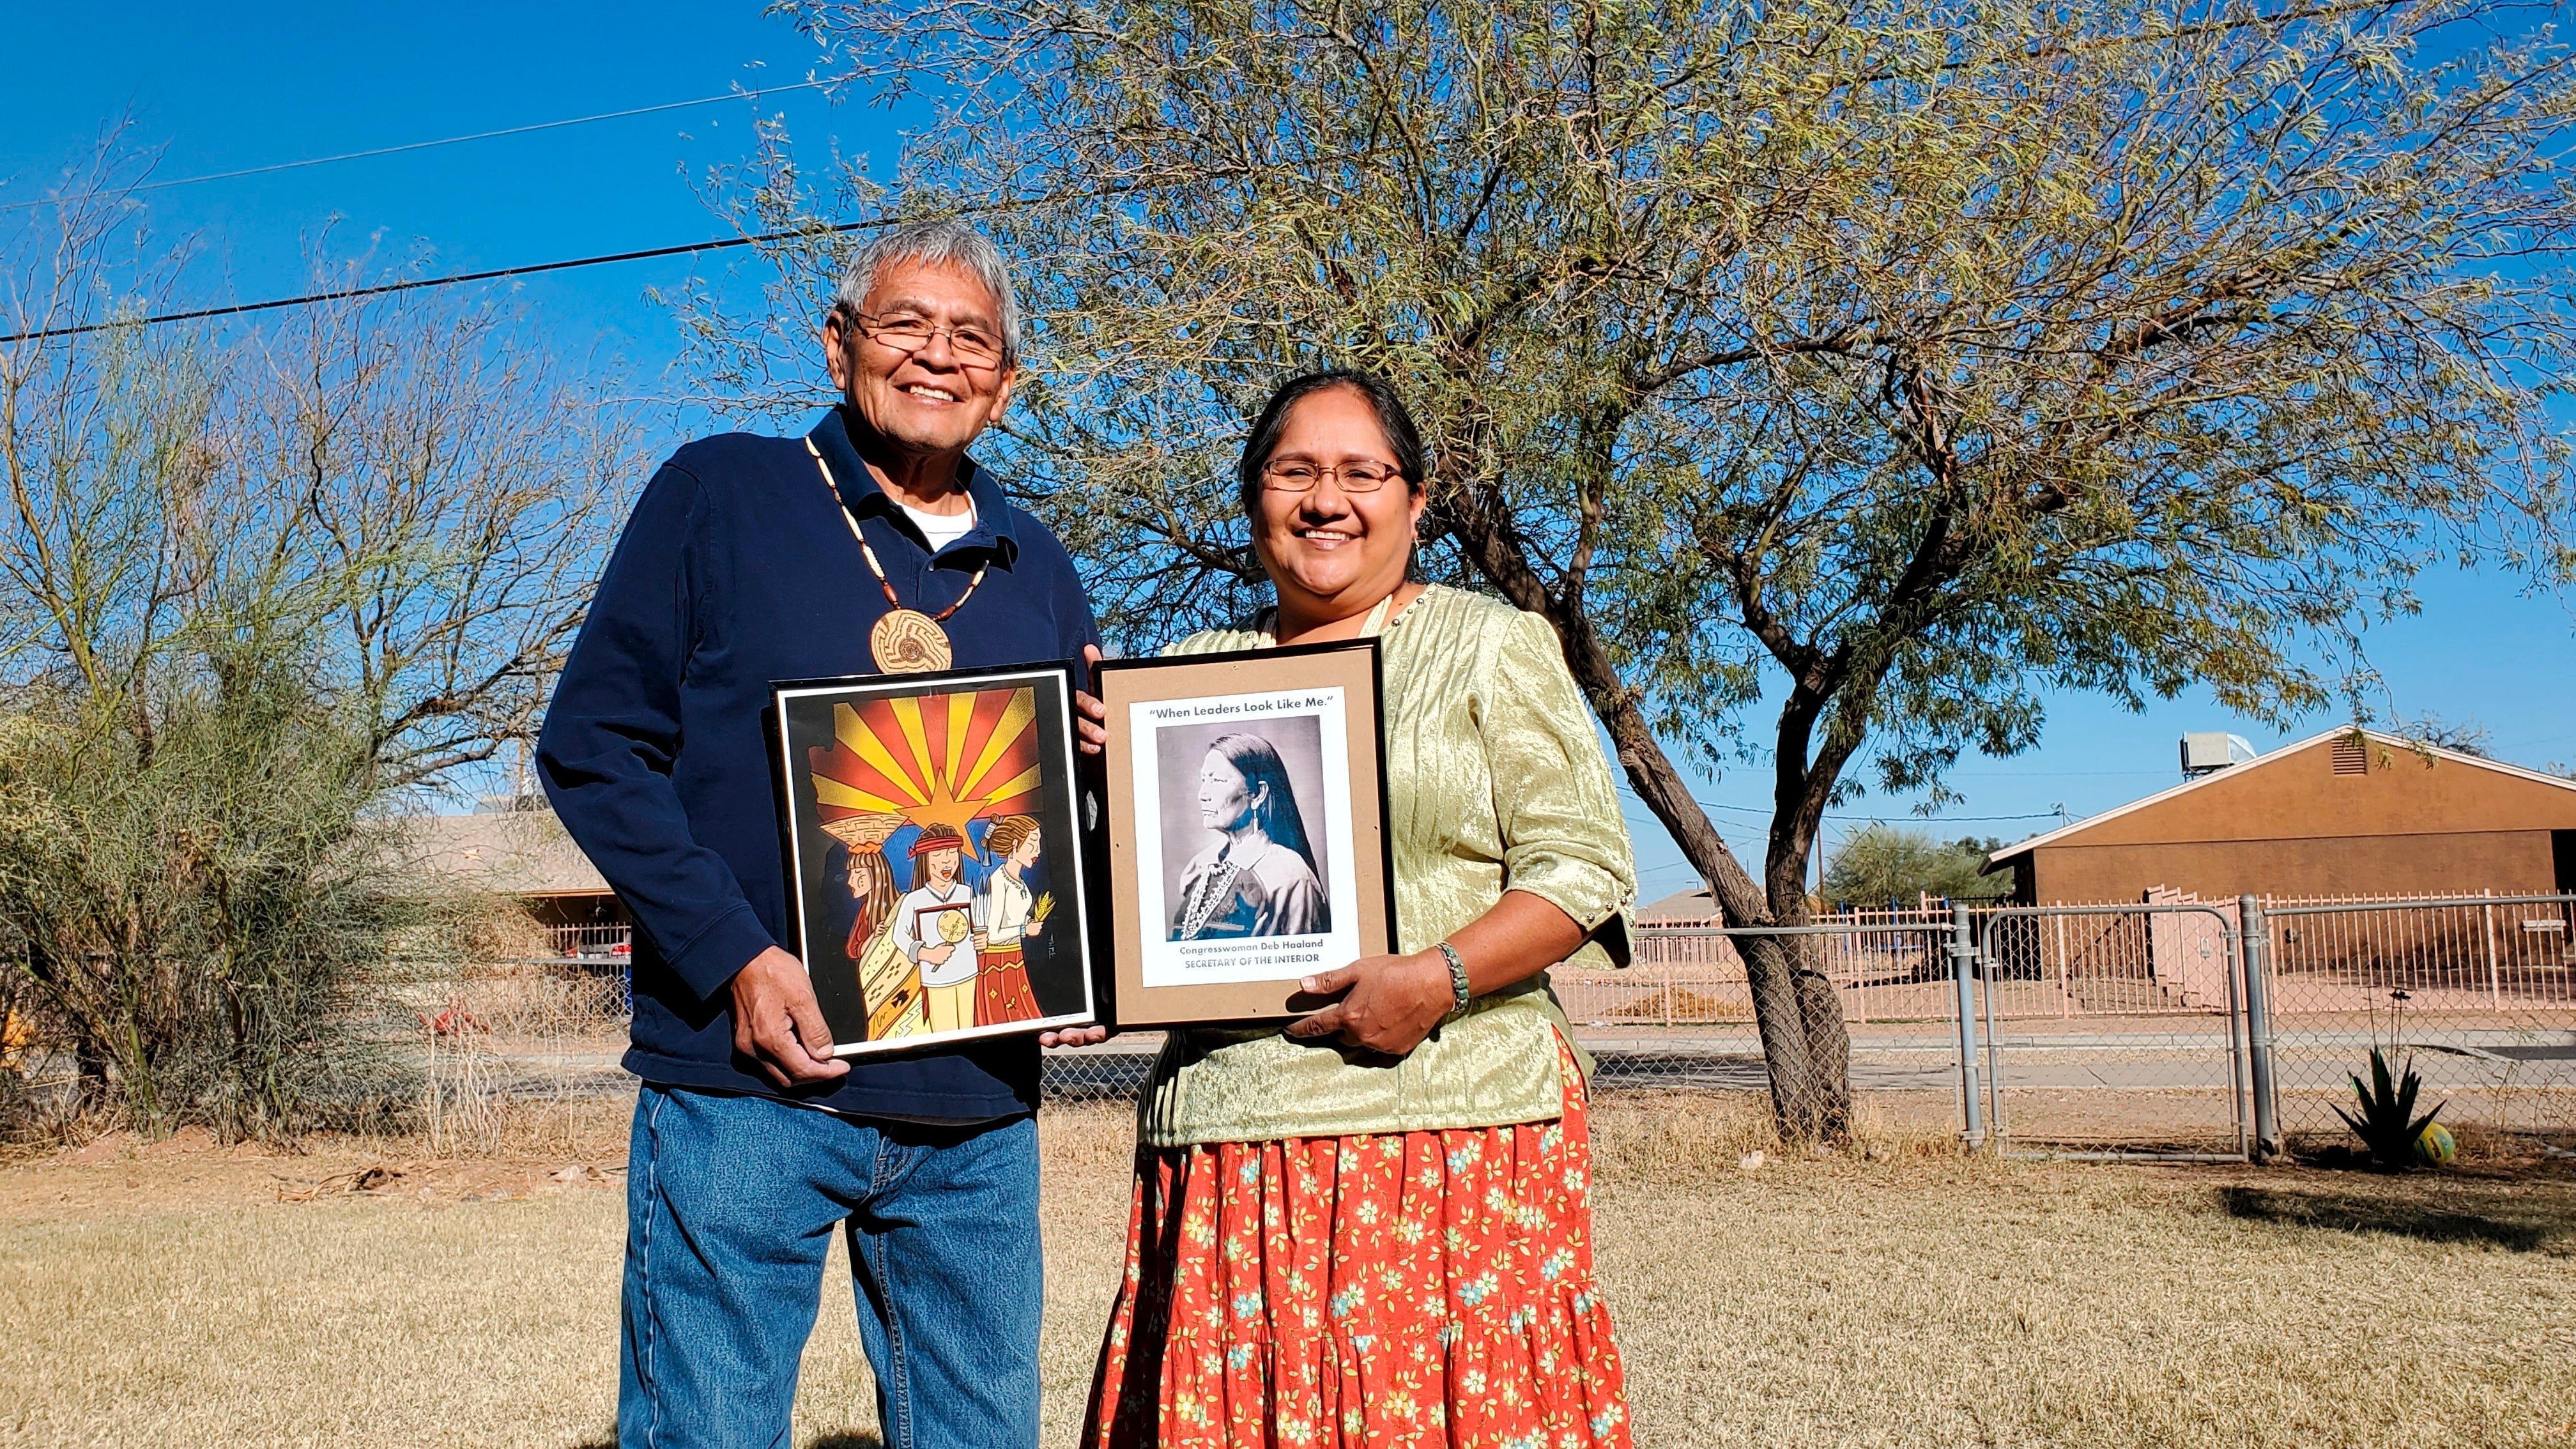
<box><xmin>536</xmin><ymin>410</ymin><xmax>1100</xmax><ymax>1121</ymax></box>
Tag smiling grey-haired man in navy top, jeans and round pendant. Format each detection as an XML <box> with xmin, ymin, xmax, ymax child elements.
<box><xmin>539</xmin><ymin>222</ymin><xmax>1098</xmax><ymax>1446</ymax></box>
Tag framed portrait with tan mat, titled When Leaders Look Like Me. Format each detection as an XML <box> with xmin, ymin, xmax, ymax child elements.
<box><xmin>1100</xmin><ymin>640</ymin><xmax>1396</xmax><ymax>1026</ymax></box>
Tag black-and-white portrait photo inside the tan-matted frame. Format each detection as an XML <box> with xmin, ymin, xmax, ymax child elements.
<box><xmin>1154</xmin><ymin>714</ymin><xmax>1332</xmax><ymax>941</ymax></box>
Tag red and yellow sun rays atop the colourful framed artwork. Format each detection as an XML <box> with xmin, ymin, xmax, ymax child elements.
<box><xmin>806</xmin><ymin>689</ymin><xmax>1038</xmax><ymax>836</ymax></box>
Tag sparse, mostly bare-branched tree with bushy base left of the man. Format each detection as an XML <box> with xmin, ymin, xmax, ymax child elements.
<box><xmin>0</xmin><ymin>150</ymin><xmax>636</xmax><ymax>1137</ymax></box>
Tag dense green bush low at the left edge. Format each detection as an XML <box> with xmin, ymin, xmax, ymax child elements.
<box><xmin>0</xmin><ymin>668</ymin><xmax>435</xmax><ymax>1137</ymax></box>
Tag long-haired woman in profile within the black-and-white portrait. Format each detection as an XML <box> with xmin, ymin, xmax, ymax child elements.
<box><xmin>1170</xmin><ymin>735</ymin><xmax>1332</xmax><ymax>941</ymax></box>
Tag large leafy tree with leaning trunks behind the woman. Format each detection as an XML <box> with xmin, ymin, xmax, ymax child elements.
<box><xmin>682</xmin><ymin>0</ymin><xmax>2571</xmax><ymax>1140</ymax></box>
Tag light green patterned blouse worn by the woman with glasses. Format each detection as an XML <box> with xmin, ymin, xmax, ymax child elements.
<box><xmin>1138</xmin><ymin>585</ymin><xmax>1636</xmax><ymax>1147</ymax></box>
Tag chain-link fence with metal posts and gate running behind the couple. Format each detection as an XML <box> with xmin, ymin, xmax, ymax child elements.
<box><xmin>376</xmin><ymin>892</ymin><xmax>2576</xmax><ymax>1155</ymax></box>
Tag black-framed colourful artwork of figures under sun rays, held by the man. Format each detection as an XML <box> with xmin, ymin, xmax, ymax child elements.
<box><xmin>773</xmin><ymin>665</ymin><xmax>1098</xmax><ymax>1057</ymax></box>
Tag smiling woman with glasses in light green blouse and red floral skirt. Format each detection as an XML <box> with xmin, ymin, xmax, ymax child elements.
<box><xmin>1084</xmin><ymin>371</ymin><xmax>1636</xmax><ymax>1449</ymax></box>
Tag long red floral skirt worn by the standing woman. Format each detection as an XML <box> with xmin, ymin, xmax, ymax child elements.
<box><xmin>1082</xmin><ymin>1036</ymin><xmax>1628</xmax><ymax>1449</ymax></box>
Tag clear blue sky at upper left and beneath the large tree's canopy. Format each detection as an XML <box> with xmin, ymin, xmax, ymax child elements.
<box><xmin>0</xmin><ymin>3</ymin><xmax>2576</xmax><ymax>897</ymax></box>
